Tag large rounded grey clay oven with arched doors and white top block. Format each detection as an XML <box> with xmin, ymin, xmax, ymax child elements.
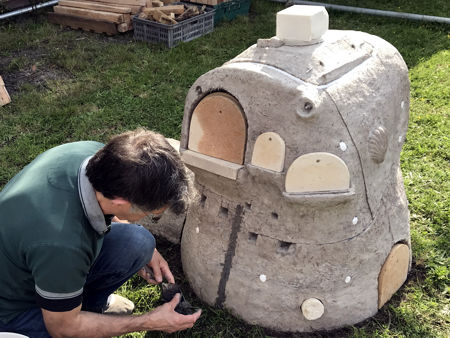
<box><xmin>158</xmin><ymin>6</ymin><xmax>411</xmax><ymax>331</ymax></box>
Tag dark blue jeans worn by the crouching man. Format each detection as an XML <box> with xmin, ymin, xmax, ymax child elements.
<box><xmin>0</xmin><ymin>223</ymin><xmax>156</xmax><ymax>338</ymax></box>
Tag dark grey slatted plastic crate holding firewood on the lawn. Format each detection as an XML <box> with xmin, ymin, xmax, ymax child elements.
<box><xmin>133</xmin><ymin>2</ymin><xmax>215</xmax><ymax>48</ymax></box>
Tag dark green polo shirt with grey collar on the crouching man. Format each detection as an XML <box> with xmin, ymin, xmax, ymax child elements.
<box><xmin>0</xmin><ymin>142</ymin><xmax>106</xmax><ymax>323</ymax></box>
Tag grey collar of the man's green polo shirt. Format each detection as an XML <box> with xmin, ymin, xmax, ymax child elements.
<box><xmin>78</xmin><ymin>156</ymin><xmax>110</xmax><ymax>235</ymax></box>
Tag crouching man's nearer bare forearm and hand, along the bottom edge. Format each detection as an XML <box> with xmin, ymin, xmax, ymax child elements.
<box><xmin>42</xmin><ymin>294</ymin><xmax>201</xmax><ymax>338</ymax></box>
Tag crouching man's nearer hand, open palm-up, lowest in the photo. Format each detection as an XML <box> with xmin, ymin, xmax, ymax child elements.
<box><xmin>144</xmin><ymin>293</ymin><xmax>202</xmax><ymax>333</ymax></box>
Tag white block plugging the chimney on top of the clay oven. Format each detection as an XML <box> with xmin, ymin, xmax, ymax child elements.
<box><xmin>276</xmin><ymin>5</ymin><xmax>328</xmax><ymax>45</ymax></box>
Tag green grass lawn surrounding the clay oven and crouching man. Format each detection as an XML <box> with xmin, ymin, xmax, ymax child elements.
<box><xmin>0</xmin><ymin>0</ymin><xmax>450</xmax><ymax>337</ymax></box>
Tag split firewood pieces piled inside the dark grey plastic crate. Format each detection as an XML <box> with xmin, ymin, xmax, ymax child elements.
<box><xmin>138</xmin><ymin>1</ymin><xmax>206</xmax><ymax>25</ymax></box>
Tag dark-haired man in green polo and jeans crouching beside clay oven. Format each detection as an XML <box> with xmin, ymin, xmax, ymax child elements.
<box><xmin>0</xmin><ymin>129</ymin><xmax>200</xmax><ymax>337</ymax></box>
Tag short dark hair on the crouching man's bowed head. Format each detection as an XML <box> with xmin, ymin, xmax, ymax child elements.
<box><xmin>86</xmin><ymin>128</ymin><xmax>191</xmax><ymax>214</ymax></box>
